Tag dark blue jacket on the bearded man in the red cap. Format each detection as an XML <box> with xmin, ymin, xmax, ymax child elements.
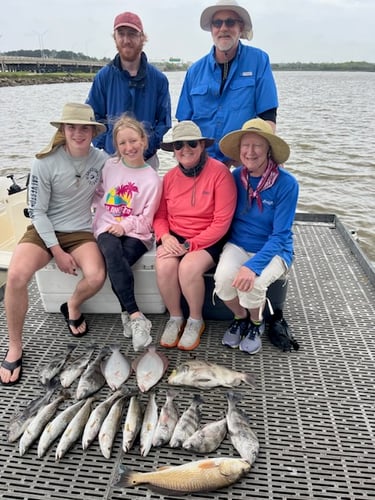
<box><xmin>86</xmin><ymin>52</ymin><xmax>172</xmax><ymax>160</ymax></box>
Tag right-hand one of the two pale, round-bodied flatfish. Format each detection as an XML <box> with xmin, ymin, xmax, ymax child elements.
<box><xmin>132</xmin><ymin>345</ymin><xmax>169</xmax><ymax>392</ymax></box>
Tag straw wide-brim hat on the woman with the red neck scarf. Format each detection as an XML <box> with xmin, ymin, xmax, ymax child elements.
<box><xmin>219</xmin><ymin>118</ymin><xmax>290</xmax><ymax>165</ymax></box>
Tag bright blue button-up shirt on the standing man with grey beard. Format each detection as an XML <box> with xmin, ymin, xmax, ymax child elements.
<box><xmin>176</xmin><ymin>42</ymin><xmax>278</xmax><ymax>162</ymax></box>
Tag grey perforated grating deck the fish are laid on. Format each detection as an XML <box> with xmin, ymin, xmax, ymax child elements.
<box><xmin>0</xmin><ymin>214</ymin><xmax>375</xmax><ymax>500</ymax></box>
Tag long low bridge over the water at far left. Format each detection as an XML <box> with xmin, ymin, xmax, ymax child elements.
<box><xmin>0</xmin><ymin>54</ymin><xmax>107</xmax><ymax>73</ymax></box>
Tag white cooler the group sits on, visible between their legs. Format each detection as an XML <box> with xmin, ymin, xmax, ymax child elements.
<box><xmin>35</xmin><ymin>249</ymin><xmax>165</xmax><ymax>314</ymax></box>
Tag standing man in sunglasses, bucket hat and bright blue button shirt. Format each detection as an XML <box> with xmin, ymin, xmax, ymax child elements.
<box><xmin>176</xmin><ymin>0</ymin><xmax>278</xmax><ymax>166</ymax></box>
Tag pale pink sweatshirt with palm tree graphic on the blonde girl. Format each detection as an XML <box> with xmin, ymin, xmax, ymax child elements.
<box><xmin>93</xmin><ymin>158</ymin><xmax>162</xmax><ymax>249</ymax></box>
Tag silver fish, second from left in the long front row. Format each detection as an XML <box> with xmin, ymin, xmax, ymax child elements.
<box><xmin>19</xmin><ymin>391</ymin><xmax>70</xmax><ymax>457</ymax></box>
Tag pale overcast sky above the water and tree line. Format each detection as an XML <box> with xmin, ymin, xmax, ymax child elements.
<box><xmin>0</xmin><ymin>0</ymin><xmax>375</xmax><ymax>63</ymax></box>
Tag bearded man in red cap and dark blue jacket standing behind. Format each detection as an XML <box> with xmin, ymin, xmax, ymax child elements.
<box><xmin>86</xmin><ymin>12</ymin><xmax>171</xmax><ymax>170</ymax></box>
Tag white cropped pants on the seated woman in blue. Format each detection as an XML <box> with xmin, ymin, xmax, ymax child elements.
<box><xmin>214</xmin><ymin>243</ymin><xmax>288</xmax><ymax>309</ymax></box>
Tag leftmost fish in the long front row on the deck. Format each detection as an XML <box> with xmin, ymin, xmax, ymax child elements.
<box><xmin>8</xmin><ymin>380</ymin><xmax>61</xmax><ymax>443</ymax></box>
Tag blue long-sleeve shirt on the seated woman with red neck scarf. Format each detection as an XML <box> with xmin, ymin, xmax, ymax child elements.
<box><xmin>229</xmin><ymin>167</ymin><xmax>299</xmax><ymax>276</ymax></box>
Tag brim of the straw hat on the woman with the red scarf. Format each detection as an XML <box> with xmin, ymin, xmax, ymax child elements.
<box><xmin>219</xmin><ymin>128</ymin><xmax>290</xmax><ymax>165</ymax></box>
